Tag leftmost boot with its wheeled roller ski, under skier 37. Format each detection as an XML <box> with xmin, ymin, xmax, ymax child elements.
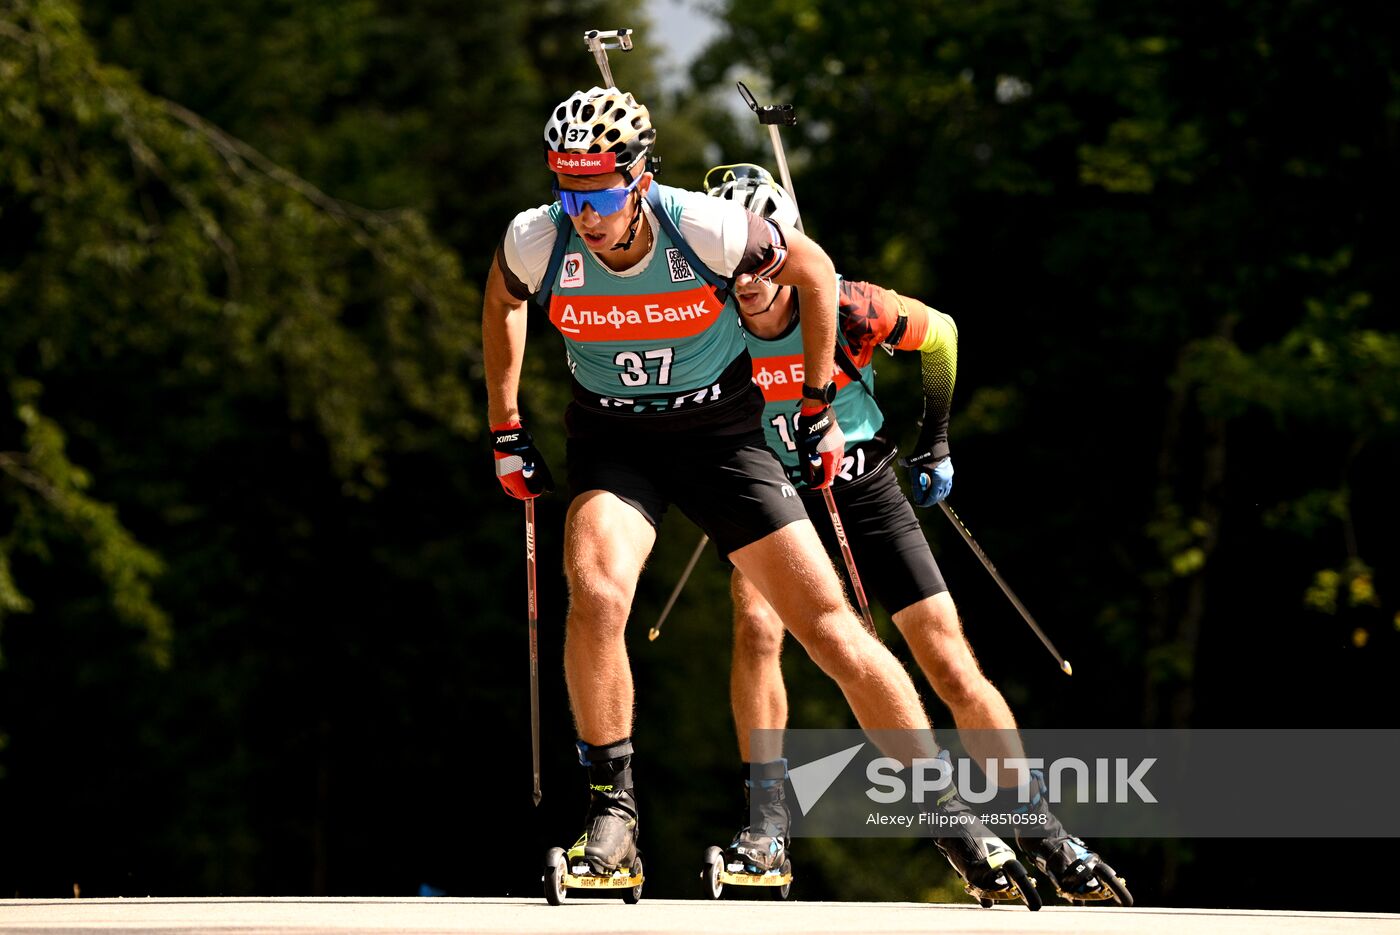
<box><xmin>543</xmin><ymin>740</ymin><xmax>643</xmax><ymax>906</ymax></box>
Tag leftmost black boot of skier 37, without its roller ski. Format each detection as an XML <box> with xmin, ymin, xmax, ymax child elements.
<box><xmin>568</xmin><ymin>739</ymin><xmax>637</xmax><ymax>876</ymax></box>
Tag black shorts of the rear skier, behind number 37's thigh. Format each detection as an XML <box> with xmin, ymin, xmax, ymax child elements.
<box><xmin>801</xmin><ymin>465</ymin><xmax>948</xmax><ymax>614</ymax></box>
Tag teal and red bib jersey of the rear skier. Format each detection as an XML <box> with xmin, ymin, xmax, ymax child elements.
<box><xmin>743</xmin><ymin>279</ymin><xmax>893</xmax><ymax>483</ymax></box>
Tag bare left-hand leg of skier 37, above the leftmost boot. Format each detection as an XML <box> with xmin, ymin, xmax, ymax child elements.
<box><xmin>564</xmin><ymin>490</ymin><xmax>657</xmax><ymax>746</ymax></box>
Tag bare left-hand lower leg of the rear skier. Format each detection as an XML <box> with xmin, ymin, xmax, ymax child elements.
<box><xmin>729</xmin><ymin>568</ymin><xmax>787</xmax><ymax>763</ymax></box>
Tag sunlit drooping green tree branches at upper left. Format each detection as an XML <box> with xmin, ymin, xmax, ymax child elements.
<box><xmin>0</xmin><ymin>3</ymin><xmax>476</xmax><ymax>640</ymax></box>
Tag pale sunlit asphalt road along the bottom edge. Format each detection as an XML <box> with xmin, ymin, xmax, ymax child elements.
<box><xmin>0</xmin><ymin>896</ymin><xmax>1400</xmax><ymax>935</ymax></box>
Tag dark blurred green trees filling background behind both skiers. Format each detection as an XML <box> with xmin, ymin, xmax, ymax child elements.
<box><xmin>0</xmin><ymin>0</ymin><xmax>1400</xmax><ymax>908</ymax></box>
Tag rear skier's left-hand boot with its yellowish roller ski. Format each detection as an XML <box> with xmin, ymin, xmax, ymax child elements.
<box><xmin>700</xmin><ymin>759</ymin><xmax>792</xmax><ymax>900</ymax></box>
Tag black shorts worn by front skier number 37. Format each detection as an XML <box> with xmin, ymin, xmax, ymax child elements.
<box><xmin>568</xmin><ymin>431</ymin><xmax>806</xmax><ymax>556</ymax></box>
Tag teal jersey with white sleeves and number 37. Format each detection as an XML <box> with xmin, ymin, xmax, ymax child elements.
<box><xmin>501</xmin><ymin>185</ymin><xmax>778</xmax><ymax>416</ymax></box>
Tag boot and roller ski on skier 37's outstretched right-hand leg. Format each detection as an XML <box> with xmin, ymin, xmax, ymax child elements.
<box><xmin>934</xmin><ymin>750</ymin><xmax>1040</xmax><ymax>913</ymax></box>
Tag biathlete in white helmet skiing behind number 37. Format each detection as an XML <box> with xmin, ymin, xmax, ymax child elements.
<box><xmin>706</xmin><ymin>164</ymin><xmax>1131</xmax><ymax>901</ymax></box>
